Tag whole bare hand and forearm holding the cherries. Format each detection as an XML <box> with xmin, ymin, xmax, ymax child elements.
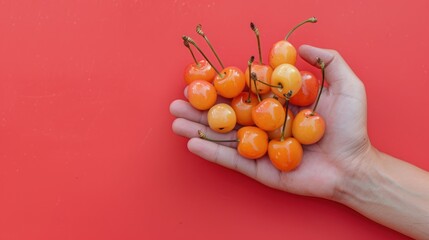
<box><xmin>170</xmin><ymin>45</ymin><xmax>429</xmax><ymax>239</ymax></box>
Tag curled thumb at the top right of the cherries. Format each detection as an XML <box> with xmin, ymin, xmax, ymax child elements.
<box><xmin>299</xmin><ymin>45</ymin><xmax>363</xmax><ymax>93</ymax></box>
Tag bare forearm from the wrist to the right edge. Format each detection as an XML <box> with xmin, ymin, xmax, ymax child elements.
<box><xmin>336</xmin><ymin>149</ymin><xmax>429</xmax><ymax>239</ymax></box>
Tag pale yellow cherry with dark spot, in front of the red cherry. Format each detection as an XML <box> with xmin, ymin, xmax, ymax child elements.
<box><xmin>271</xmin><ymin>63</ymin><xmax>302</xmax><ymax>98</ymax></box>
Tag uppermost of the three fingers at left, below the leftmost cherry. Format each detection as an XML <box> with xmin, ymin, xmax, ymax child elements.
<box><xmin>170</xmin><ymin>99</ymin><xmax>208</xmax><ymax>125</ymax></box>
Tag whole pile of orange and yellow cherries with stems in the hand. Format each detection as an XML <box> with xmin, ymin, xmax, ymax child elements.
<box><xmin>183</xmin><ymin>17</ymin><xmax>325</xmax><ymax>171</ymax></box>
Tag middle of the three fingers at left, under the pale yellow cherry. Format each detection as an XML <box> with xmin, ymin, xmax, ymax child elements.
<box><xmin>172</xmin><ymin>118</ymin><xmax>237</xmax><ymax>148</ymax></box>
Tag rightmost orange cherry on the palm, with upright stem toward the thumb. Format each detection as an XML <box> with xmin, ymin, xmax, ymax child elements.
<box><xmin>292</xmin><ymin>58</ymin><xmax>326</xmax><ymax>144</ymax></box>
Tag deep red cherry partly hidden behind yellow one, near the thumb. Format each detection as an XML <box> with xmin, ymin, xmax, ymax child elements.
<box><xmin>290</xmin><ymin>71</ymin><xmax>319</xmax><ymax>107</ymax></box>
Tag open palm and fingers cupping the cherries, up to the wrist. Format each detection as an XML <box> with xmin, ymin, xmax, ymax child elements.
<box><xmin>170</xmin><ymin>45</ymin><xmax>372</xmax><ymax>200</ymax></box>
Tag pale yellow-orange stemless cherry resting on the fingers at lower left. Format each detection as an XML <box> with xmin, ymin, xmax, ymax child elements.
<box><xmin>207</xmin><ymin>103</ymin><xmax>237</xmax><ymax>133</ymax></box>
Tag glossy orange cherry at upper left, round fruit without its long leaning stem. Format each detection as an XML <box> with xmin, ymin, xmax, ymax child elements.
<box><xmin>213</xmin><ymin>67</ymin><xmax>246</xmax><ymax>98</ymax></box>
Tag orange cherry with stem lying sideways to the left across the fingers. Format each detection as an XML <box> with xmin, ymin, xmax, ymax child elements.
<box><xmin>198</xmin><ymin>126</ymin><xmax>268</xmax><ymax>159</ymax></box>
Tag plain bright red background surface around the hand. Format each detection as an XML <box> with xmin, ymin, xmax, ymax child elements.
<box><xmin>0</xmin><ymin>0</ymin><xmax>429</xmax><ymax>239</ymax></box>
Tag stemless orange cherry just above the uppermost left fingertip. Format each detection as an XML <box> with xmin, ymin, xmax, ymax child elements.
<box><xmin>187</xmin><ymin>80</ymin><xmax>217</xmax><ymax>110</ymax></box>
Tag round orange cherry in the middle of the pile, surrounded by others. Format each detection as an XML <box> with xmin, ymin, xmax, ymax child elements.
<box><xmin>252</xmin><ymin>98</ymin><xmax>286</xmax><ymax>131</ymax></box>
